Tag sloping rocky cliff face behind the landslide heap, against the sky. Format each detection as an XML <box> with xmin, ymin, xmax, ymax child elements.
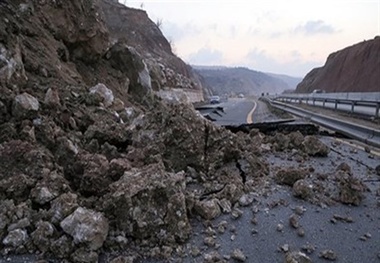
<box><xmin>100</xmin><ymin>0</ymin><xmax>202</xmax><ymax>100</ymax></box>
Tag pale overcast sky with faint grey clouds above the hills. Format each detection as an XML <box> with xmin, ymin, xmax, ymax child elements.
<box><xmin>119</xmin><ymin>0</ymin><xmax>380</xmax><ymax>77</ymax></box>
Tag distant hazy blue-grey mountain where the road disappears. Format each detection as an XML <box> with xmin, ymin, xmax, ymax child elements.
<box><xmin>192</xmin><ymin>66</ymin><xmax>294</xmax><ymax>96</ymax></box>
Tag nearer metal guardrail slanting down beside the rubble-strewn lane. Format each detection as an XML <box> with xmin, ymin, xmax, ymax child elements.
<box><xmin>268</xmin><ymin>99</ymin><xmax>380</xmax><ymax>148</ymax></box>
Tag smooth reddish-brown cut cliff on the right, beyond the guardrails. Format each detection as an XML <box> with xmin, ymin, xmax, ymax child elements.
<box><xmin>296</xmin><ymin>37</ymin><xmax>380</xmax><ymax>93</ymax></box>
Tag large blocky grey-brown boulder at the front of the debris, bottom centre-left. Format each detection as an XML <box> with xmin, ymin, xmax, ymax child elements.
<box><xmin>103</xmin><ymin>164</ymin><xmax>191</xmax><ymax>243</ymax></box>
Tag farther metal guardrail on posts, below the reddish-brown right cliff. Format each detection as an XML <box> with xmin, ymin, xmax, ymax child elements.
<box><xmin>271</xmin><ymin>92</ymin><xmax>380</xmax><ymax>118</ymax></box>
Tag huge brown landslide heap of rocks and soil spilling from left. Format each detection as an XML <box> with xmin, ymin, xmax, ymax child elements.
<box><xmin>0</xmin><ymin>0</ymin><xmax>268</xmax><ymax>262</ymax></box>
